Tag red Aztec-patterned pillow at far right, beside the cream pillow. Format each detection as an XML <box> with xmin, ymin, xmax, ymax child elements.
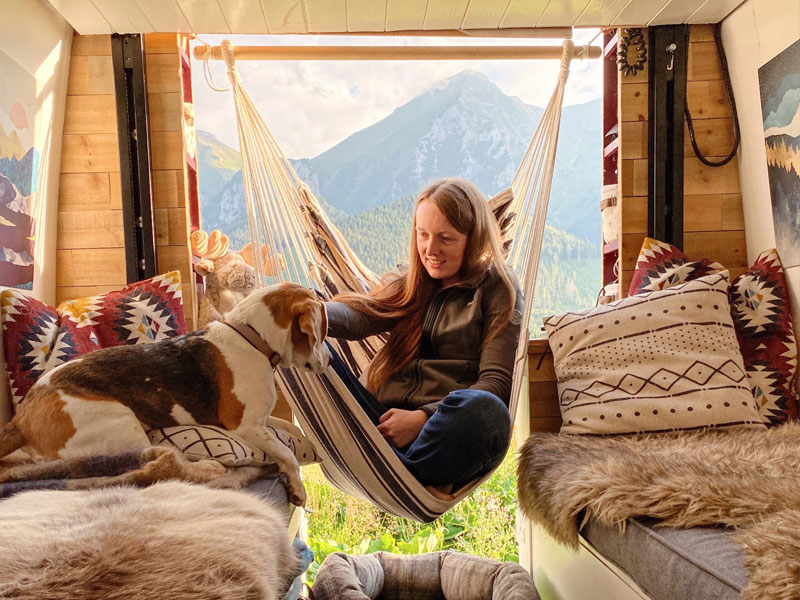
<box><xmin>730</xmin><ymin>249</ymin><xmax>798</xmax><ymax>425</ymax></box>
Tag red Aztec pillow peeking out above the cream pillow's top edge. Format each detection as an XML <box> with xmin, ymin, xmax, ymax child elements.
<box><xmin>628</xmin><ymin>238</ymin><xmax>725</xmax><ymax>296</ymax></box>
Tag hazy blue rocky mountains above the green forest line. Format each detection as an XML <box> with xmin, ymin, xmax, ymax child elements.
<box><xmin>198</xmin><ymin>71</ymin><xmax>601</xmax><ymax>240</ymax></box>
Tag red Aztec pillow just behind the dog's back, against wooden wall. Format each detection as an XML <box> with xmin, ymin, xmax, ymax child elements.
<box><xmin>56</xmin><ymin>271</ymin><xmax>186</xmax><ymax>348</ymax></box>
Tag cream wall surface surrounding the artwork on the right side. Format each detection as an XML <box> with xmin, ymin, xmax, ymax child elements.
<box><xmin>722</xmin><ymin>0</ymin><xmax>800</xmax><ymax>331</ymax></box>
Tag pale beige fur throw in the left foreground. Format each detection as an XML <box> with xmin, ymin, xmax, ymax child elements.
<box><xmin>0</xmin><ymin>482</ymin><xmax>298</xmax><ymax>600</ymax></box>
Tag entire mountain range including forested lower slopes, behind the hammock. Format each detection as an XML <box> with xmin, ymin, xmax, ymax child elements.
<box><xmin>198</xmin><ymin>71</ymin><xmax>602</xmax><ymax>318</ymax></box>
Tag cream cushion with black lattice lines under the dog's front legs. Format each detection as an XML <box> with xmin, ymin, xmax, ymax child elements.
<box><xmin>147</xmin><ymin>417</ymin><xmax>320</xmax><ymax>467</ymax></box>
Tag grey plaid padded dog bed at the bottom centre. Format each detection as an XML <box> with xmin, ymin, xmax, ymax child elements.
<box><xmin>312</xmin><ymin>551</ymin><xmax>539</xmax><ymax>600</ymax></box>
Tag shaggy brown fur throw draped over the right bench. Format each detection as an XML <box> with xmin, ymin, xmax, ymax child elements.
<box><xmin>518</xmin><ymin>422</ymin><xmax>800</xmax><ymax>600</ymax></box>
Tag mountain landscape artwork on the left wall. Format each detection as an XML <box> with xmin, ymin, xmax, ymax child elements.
<box><xmin>0</xmin><ymin>51</ymin><xmax>41</xmax><ymax>290</ymax></box>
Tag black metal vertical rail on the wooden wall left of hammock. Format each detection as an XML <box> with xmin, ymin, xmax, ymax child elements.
<box><xmin>111</xmin><ymin>34</ymin><xmax>157</xmax><ymax>283</ymax></box>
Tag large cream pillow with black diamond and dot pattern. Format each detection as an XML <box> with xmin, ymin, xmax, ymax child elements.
<box><xmin>544</xmin><ymin>271</ymin><xmax>763</xmax><ymax>434</ymax></box>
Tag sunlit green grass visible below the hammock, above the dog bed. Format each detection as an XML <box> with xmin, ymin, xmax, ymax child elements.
<box><xmin>303</xmin><ymin>442</ymin><xmax>519</xmax><ymax>583</ymax></box>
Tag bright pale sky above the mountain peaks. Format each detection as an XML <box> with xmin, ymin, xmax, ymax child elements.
<box><xmin>192</xmin><ymin>29</ymin><xmax>602</xmax><ymax>158</ymax></box>
